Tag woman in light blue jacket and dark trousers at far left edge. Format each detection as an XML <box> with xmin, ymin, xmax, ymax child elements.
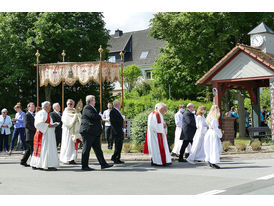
<box><xmin>0</xmin><ymin>108</ymin><xmax>12</xmax><ymax>153</ymax></box>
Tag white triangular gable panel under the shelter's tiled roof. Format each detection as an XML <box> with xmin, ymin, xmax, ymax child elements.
<box><xmin>212</xmin><ymin>52</ymin><xmax>274</xmax><ymax>80</ymax></box>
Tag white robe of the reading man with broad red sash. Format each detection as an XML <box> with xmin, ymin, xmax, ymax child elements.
<box><xmin>30</xmin><ymin>109</ymin><xmax>59</xmax><ymax>169</ymax></box>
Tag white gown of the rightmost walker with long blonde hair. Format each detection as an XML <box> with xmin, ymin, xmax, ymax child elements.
<box><xmin>204</xmin><ymin>119</ymin><xmax>223</xmax><ymax>164</ymax></box>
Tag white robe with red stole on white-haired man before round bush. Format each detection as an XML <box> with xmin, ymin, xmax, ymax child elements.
<box><xmin>147</xmin><ymin>112</ymin><xmax>171</xmax><ymax>165</ymax></box>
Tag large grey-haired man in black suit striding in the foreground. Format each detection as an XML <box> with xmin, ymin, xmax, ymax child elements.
<box><xmin>80</xmin><ymin>95</ymin><xmax>113</xmax><ymax>171</ymax></box>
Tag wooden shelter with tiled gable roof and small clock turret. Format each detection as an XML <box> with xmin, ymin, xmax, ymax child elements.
<box><xmin>196</xmin><ymin>23</ymin><xmax>274</xmax><ymax>142</ymax></box>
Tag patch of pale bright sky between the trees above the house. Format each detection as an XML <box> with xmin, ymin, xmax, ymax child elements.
<box><xmin>103</xmin><ymin>11</ymin><xmax>156</xmax><ymax>34</ymax></box>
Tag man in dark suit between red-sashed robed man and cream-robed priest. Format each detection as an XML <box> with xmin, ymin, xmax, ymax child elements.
<box><xmin>49</xmin><ymin>103</ymin><xmax>62</xmax><ymax>148</ymax></box>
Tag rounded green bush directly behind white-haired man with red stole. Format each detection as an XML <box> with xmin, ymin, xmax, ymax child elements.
<box><xmin>132</xmin><ymin>111</ymin><xmax>175</xmax><ymax>150</ymax></box>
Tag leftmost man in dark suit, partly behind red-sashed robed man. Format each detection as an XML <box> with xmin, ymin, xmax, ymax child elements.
<box><xmin>20</xmin><ymin>102</ymin><xmax>36</xmax><ymax>167</ymax></box>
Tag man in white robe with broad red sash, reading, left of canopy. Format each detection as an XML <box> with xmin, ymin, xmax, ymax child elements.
<box><xmin>30</xmin><ymin>101</ymin><xmax>59</xmax><ymax>171</ymax></box>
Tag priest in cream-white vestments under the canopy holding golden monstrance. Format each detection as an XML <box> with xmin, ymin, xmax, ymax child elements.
<box><xmin>60</xmin><ymin>99</ymin><xmax>82</xmax><ymax>164</ymax></box>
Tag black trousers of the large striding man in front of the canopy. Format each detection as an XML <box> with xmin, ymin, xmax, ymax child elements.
<box><xmin>81</xmin><ymin>134</ymin><xmax>107</xmax><ymax>168</ymax></box>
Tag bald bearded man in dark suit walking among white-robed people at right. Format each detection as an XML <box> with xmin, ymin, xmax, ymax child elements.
<box><xmin>179</xmin><ymin>103</ymin><xmax>197</xmax><ymax>162</ymax></box>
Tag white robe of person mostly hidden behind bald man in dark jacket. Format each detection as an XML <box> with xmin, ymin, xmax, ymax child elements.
<box><xmin>171</xmin><ymin>111</ymin><xmax>191</xmax><ymax>155</ymax></box>
